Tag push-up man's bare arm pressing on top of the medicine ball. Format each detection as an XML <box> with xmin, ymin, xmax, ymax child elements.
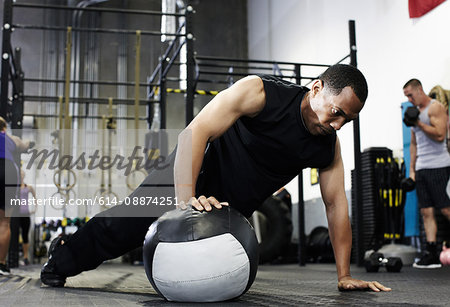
<box><xmin>174</xmin><ymin>76</ymin><xmax>265</xmax><ymax>209</ymax></box>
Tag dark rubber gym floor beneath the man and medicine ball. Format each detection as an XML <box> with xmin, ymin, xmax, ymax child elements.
<box><xmin>0</xmin><ymin>263</ymin><xmax>450</xmax><ymax>307</ymax></box>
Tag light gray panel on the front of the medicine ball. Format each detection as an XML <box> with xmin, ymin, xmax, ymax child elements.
<box><xmin>152</xmin><ymin>233</ymin><xmax>250</xmax><ymax>302</ymax></box>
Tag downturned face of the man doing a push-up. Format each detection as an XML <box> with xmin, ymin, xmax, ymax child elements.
<box><xmin>308</xmin><ymin>81</ymin><xmax>364</xmax><ymax>135</ymax></box>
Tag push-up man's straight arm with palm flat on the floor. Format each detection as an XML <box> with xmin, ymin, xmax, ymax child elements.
<box><xmin>319</xmin><ymin>139</ymin><xmax>391</xmax><ymax>292</ymax></box>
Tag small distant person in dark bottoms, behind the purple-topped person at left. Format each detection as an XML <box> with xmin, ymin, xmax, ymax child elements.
<box><xmin>19</xmin><ymin>169</ymin><xmax>36</xmax><ymax>265</ymax></box>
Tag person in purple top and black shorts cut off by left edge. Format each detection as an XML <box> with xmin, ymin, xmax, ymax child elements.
<box><xmin>0</xmin><ymin>117</ymin><xmax>34</xmax><ymax>275</ymax></box>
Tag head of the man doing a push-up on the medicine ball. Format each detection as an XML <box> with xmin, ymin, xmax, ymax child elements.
<box><xmin>302</xmin><ymin>64</ymin><xmax>368</xmax><ymax>135</ymax></box>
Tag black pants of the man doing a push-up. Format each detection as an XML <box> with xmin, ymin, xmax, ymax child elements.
<box><xmin>49</xmin><ymin>152</ymin><xmax>175</xmax><ymax>276</ymax></box>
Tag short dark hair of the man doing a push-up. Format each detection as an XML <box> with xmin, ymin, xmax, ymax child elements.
<box><xmin>319</xmin><ymin>64</ymin><xmax>368</xmax><ymax>103</ymax></box>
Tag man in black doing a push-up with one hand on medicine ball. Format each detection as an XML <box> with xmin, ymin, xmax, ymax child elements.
<box><xmin>41</xmin><ymin>64</ymin><xmax>391</xmax><ymax>292</ymax></box>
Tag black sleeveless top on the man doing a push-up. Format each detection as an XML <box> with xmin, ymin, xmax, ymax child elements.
<box><xmin>196</xmin><ymin>75</ymin><xmax>336</xmax><ymax>217</ymax></box>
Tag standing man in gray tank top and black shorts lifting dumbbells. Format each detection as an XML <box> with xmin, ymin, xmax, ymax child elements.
<box><xmin>403</xmin><ymin>79</ymin><xmax>450</xmax><ymax>268</ymax></box>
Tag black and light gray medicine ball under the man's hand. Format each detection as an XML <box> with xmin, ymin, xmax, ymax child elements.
<box><xmin>143</xmin><ymin>206</ymin><xmax>258</xmax><ymax>302</ymax></box>
